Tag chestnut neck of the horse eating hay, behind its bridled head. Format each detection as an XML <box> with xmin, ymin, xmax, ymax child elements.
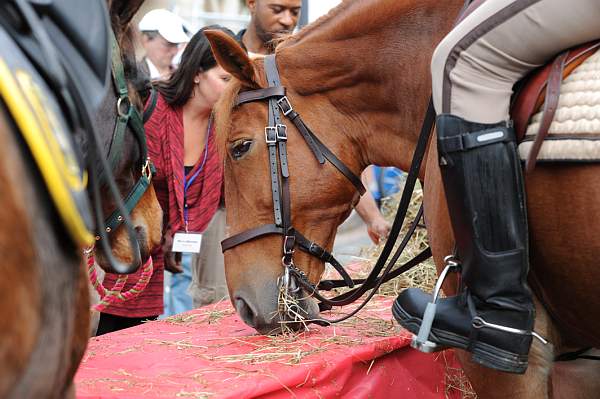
<box><xmin>277</xmin><ymin>0</ymin><xmax>462</xmax><ymax>170</ymax></box>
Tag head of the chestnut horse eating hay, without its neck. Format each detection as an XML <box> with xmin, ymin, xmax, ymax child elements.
<box><xmin>207</xmin><ymin>32</ymin><xmax>363</xmax><ymax>333</ymax></box>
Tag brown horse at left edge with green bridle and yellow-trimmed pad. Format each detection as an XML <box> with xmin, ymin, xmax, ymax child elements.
<box><xmin>0</xmin><ymin>0</ymin><xmax>162</xmax><ymax>398</ymax></box>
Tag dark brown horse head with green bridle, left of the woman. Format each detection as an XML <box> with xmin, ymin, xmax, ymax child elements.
<box><xmin>95</xmin><ymin>0</ymin><xmax>162</xmax><ymax>271</ymax></box>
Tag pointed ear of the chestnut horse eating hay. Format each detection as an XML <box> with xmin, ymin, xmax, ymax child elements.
<box><xmin>204</xmin><ymin>30</ymin><xmax>258</xmax><ymax>87</ymax></box>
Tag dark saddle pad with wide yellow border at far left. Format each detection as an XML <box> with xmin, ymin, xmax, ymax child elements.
<box><xmin>0</xmin><ymin>27</ymin><xmax>94</xmax><ymax>246</ymax></box>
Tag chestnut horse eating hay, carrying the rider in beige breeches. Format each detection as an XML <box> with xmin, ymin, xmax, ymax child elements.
<box><xmin>207</xmin><ymin>0</ymin><xmax>600</xmax><ymax>398</ymax></box>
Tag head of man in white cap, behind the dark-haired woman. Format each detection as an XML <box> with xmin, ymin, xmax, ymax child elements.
<box><xmin>138</xmin><ymin>9</ymin><xmax>189</xmax><ymax>80</ymax></box>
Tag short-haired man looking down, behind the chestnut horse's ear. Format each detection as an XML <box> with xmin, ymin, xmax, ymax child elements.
<box><xmin>237</xmin><ymin>0</ymin><xmax>302</xmax><ymax>54</ymax></box>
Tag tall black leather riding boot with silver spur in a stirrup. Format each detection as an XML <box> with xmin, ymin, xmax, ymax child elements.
<box><xmin>393</xmin><ymin>115</ymin><xmax>535</xmax><ymax>373</ymax></box>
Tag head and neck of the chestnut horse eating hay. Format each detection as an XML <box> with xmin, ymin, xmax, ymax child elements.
<box><xmin>207</xmin><ymin>1</ymin><xmax>459</xmax><ymax>333</ymax></box>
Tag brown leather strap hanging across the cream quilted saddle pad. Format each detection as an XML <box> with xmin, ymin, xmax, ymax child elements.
<box><xmin>525</xmin><ymin>51</ymin><xmax>569</xmax><ymax>173</ymax></box>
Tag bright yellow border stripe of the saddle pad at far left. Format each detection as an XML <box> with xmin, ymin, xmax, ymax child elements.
<box><xmin>0</xmin><ymin>59</ymin><xmax>94</xmax><ymax>246</ymax></box>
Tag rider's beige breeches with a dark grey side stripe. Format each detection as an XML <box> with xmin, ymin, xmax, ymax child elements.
<box><xmin>431</xmin><ymin>0</ymin><xmax>600</xmax><ymax>123</ymax></box>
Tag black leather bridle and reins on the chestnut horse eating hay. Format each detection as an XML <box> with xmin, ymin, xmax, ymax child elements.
<box><xmin>221</xmin><ymin>55</ymin><xmax>435</xmax><ymax>324</ymax></box>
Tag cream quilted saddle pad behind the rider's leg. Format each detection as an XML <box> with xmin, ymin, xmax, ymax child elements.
<box><xmin>519</xmin><ymin>51</ymin><xmax>600</xmax><ymax>162</ymax></box>
